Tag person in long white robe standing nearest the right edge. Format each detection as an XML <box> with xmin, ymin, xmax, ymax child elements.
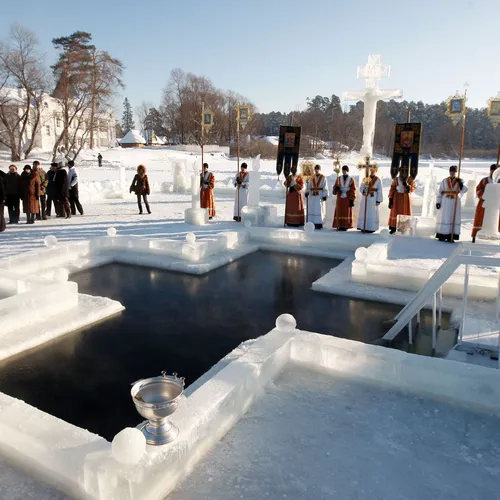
<box><xmin>436</xmin><ymin>165</ymin><xmax>467</xmax><ymax>242</ymax></box>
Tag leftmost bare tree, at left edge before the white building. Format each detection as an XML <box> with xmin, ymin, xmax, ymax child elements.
<box><xmin>0</xmin><ymin>24</ymin><xmax>47</xmax><ymax>161</ymax></box>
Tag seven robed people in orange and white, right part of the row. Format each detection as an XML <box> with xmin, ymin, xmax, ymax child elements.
<box><xmin>285</xmin><ymin>165</ymin><xmax>500</xmax><ymax>242</ymax></box>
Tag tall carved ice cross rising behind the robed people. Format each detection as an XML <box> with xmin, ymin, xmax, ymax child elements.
<box><xmin>342</xmin><ymin>55</ymin><xmax>403</xmax><ymax>157</ymax></box>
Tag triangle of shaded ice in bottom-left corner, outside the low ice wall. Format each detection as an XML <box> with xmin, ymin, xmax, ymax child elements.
<box><xmin>0</xmin><ymin>458</ymin><xmax>70</xmax><ymax>500</ymax></box>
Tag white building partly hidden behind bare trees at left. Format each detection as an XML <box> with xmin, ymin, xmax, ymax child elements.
<box><xmin>0</xmin><ymin>88</ymin><xmax>116</xmax><ymax>151</ymax></box>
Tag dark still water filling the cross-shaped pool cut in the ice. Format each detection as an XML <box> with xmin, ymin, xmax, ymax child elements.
<box><xmin>0</xmin><ymin>252</ymin><xmax>448</xmax><ymax>439</ymax></box>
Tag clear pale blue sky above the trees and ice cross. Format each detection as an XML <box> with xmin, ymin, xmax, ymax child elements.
<box><xmin>0</xmin><ymin>0</ymin><xmax>500</xmax><ymax>112</ymax></box>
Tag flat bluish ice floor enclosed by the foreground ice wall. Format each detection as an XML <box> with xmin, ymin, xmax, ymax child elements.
<box><xmin>168</xmin><ymin>365</ymin><xmax>500</xmax><ymax>500</ymax></box>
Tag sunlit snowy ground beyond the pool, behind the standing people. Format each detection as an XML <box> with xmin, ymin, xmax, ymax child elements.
<box><xmin>0</xmin><ymin>147</ymin><xmax>489</xmax><ymax>258</ymax></box>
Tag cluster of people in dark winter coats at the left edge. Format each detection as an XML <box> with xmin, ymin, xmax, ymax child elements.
<box><xmin>0</xmin><ymin>160</ymin><xmax>83</xmax><ymax>231</ymax></box>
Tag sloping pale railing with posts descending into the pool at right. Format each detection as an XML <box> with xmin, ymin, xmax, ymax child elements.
<box><xmin>383</xmin><ymin>243</ymin><xmax>500</xmax><ymax>356</ymax></box>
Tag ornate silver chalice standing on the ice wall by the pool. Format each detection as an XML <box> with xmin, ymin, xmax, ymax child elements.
<box><xmin>130</xmin><ymin>371</ymin><xmax>184</xmax><ymax>446</ymax></box>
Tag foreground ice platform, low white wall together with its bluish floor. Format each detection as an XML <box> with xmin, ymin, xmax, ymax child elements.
<box><xmin>0</xmin><ymin>318</ymin><xmax>500</xmax><ymax>500</ymax></box>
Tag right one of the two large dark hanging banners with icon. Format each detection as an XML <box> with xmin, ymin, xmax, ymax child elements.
<box><xmin>391</xmin><ymin>123</ymin><xmax>422</xmax><ymax>179</ymax></box>
